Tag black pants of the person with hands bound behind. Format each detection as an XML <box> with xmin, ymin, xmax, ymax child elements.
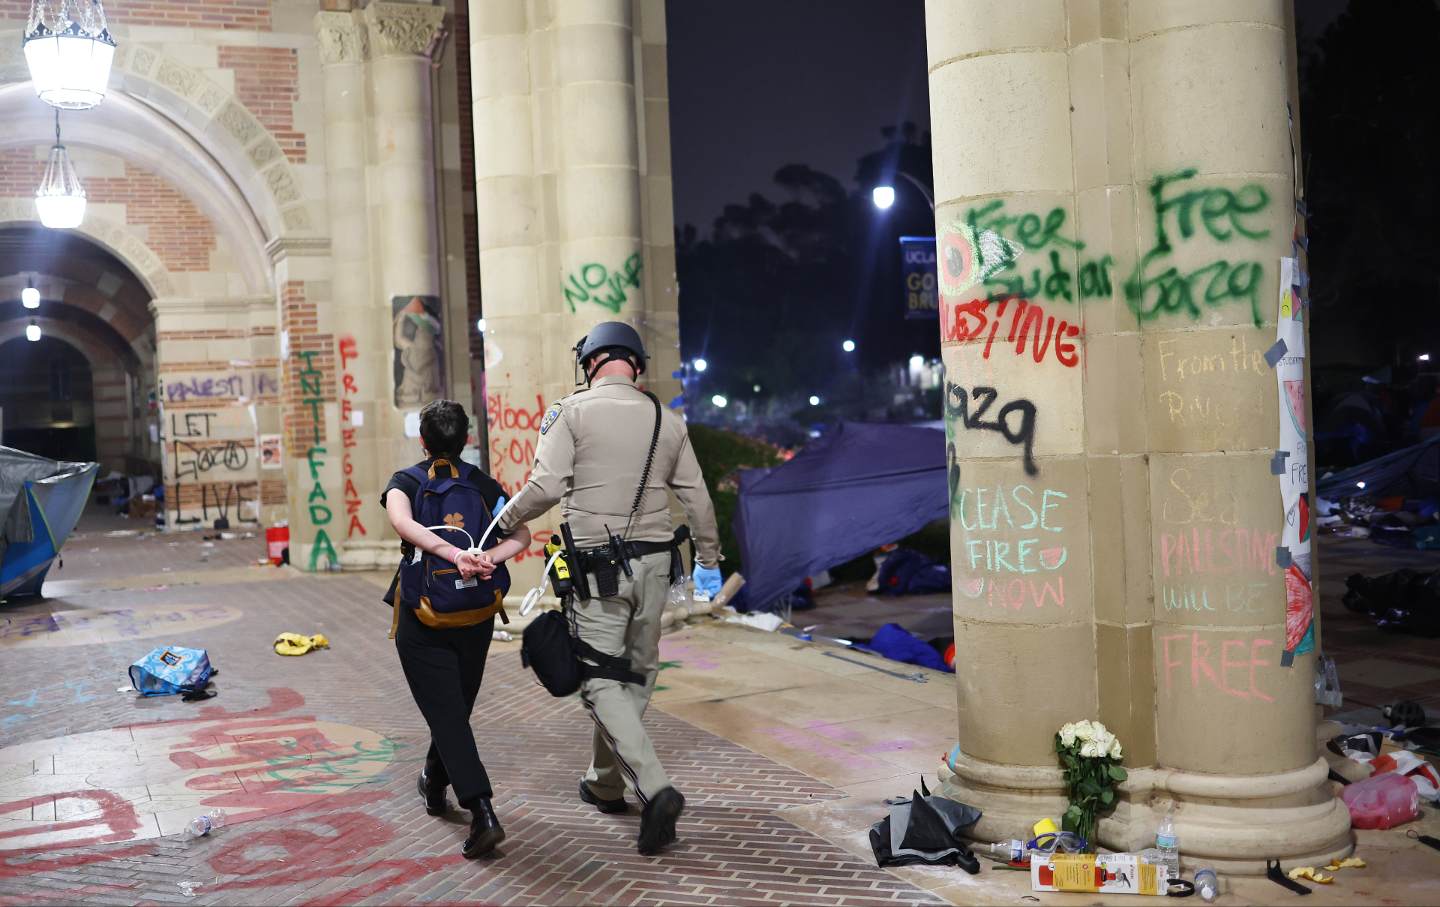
<box><xmin>395</xmin><ymin>605</ymin><xmax>495</xmax><ymax>809</ymax></box>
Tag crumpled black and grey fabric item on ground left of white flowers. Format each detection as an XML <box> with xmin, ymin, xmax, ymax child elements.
<box><xmin>870</xmin><ymin>779</ymin><xmax>981</xmax><ymax>875</ymax></box>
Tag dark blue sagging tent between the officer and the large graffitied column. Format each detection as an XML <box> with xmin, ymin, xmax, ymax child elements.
<box><xmin>734</xmin><ymin>422</ymin><xmax>949</xmax><ymax>609</ymax></box>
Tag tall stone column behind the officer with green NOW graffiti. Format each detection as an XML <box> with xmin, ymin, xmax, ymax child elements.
<box><xmin>469</xmin><ymin>0</ymin><xmax>678</xmax><ymax>583</ymax></box>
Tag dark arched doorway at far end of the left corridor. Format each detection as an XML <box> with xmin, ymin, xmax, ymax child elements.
<box><xmin>0</xmin><ymin>337</ymin><xmax>95</xmax><ymax>461</ymax></box>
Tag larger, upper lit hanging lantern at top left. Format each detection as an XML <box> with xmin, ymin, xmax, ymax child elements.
<box><xmin>24</xmin><ymin>0</ymin><xmax>115</xmax><ymax>111</ymax></box>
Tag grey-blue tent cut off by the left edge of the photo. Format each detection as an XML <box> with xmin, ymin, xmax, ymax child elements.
<box><xmin>0</xmin><ymin>448</ymin><xmax>99</xmax><ymax>599</ymax></box>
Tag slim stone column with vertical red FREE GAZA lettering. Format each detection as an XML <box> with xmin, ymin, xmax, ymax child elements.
<box><xmin>315</xmin><ymin>12</ymin><xmax>385</xmax><ymax>570</ymax></box>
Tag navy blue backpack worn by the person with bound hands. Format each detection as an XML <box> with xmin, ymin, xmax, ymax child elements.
<box><xmin>396</xmin><ymin>458</ymin><xmax>510</xmax><ymax>629</ymax></box>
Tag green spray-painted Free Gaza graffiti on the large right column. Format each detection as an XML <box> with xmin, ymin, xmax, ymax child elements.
<box><xmin>1125</xmin><ymin>168</ymin><xmax>1270</xmax><ymax>327</ymax></box>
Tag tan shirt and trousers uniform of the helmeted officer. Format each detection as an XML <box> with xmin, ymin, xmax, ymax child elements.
<box><xmin>501</xmin><ymin>376</ymin><xmax>720</xmax><ymax>805</ymax></box>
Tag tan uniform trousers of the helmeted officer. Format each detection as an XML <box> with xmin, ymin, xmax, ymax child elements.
<box><xmin>575</xmin><ymin>551</ymin><xmax>671</xmax><ymax>805</ymax></box>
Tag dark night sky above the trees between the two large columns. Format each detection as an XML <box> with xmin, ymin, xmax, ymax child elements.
<box><xmin>665</xmin><ymin>0</ymin><xmax>930</xmax><ymax>233</ymax></box>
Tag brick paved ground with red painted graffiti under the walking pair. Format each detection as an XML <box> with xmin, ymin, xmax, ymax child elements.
<box><xmin>0</xmin><ymin>524</ymin><xmax>940</xmax><ymax>904</ymax></box>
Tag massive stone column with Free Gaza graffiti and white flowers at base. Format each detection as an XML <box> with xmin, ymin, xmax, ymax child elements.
<box><xmin>927</xmin><ymin>0</ymin><xmax>1349</xmax><ymax>871</ymax></box>
